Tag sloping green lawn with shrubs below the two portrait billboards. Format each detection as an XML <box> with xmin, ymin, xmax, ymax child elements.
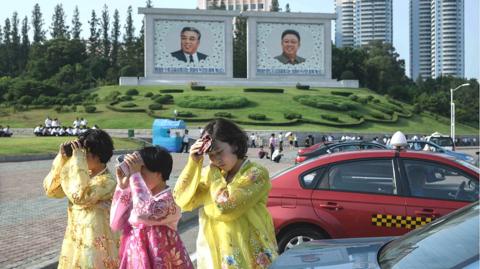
<box><xmin>0</xmin><ymin>86</ymin><xmax>478</xmax><ymax>135</ymax></box>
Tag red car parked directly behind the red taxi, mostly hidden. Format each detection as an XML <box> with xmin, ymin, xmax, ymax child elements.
<box><xmin>295</xmin><ymin>140</ymin><xmax>387</xmax><ymax>163</ymax></box>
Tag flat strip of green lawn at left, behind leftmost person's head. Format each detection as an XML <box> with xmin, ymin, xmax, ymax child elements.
<box><xmin>0</xmin><ymin>137</ymin><xmax>143</xmax><ymax>156</ymax></box>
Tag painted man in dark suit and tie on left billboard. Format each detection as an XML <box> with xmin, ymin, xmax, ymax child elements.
<box><xmin>170</xmin><ymin>27</ymin><xmax>208</xmax><ymax>63</ymax></box>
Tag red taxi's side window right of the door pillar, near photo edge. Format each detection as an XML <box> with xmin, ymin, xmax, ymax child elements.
<box><xmin>404</xmin><ymin>160</ymin><xmax>478</xmax><ymax>202</ymax></box>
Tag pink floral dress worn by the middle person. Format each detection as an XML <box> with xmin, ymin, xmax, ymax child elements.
<box><xmin>110</xmin><ymin>173</ymin><xmax>193</xmax><ymax>269</ymax></box>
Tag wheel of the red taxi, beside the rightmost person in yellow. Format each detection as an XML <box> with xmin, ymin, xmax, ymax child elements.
<box><xmin>278</xmin><ymin>226</ymin><xmax>327</xmax><ymax>253</ymax></box>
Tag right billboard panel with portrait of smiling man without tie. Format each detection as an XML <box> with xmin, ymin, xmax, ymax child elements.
<box><xmin>256</xmin><ymin>22</ymin><xmax>325</xmax><ymax>76</ymax></box>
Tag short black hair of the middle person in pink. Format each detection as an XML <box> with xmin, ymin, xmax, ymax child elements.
<box><xmin>139</xmin><ymin>146</ymin><xmax>173</xmax><ymax>181</ymax></box>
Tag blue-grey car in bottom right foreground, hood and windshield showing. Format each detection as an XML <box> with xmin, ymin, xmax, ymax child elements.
<box><xmin>270</xmin><ymin>202</ymin><xmax>480</xmax><ymax>269</ymax></box>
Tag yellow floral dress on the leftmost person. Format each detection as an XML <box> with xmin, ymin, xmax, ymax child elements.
<box><xmin>43</xmin><ymin>150</ymin><xmax>119</xmax><ymax>269</ymax></box>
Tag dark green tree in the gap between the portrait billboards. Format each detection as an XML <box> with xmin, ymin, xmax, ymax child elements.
<box><xmin>233</xmin><ymin>16</ymin><xmax>247</xmax><ymax>78</ymax></box>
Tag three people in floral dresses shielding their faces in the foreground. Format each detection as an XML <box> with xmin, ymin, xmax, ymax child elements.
<box><xmin>43</xmin><ymin>119</ymin><xmax>278</xmax><ymax>269</ymax></box>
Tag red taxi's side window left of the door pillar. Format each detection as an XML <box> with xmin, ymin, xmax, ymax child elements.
<box><xmin>320</xmin><ymin>159</ymin><xmax>397</xmax><ymax>194</ymax></box>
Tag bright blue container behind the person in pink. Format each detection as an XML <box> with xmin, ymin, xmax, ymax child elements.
<box><xmin>152</xmin><ymin>119</ymin><xmax>186</xmax><ymax>152</ymax></box>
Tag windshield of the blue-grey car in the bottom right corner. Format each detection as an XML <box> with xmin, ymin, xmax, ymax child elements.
<box><xmin>379</xmin><ymin>202</ymin><xmax>479</xmax><ymax>268</ymax></box>
